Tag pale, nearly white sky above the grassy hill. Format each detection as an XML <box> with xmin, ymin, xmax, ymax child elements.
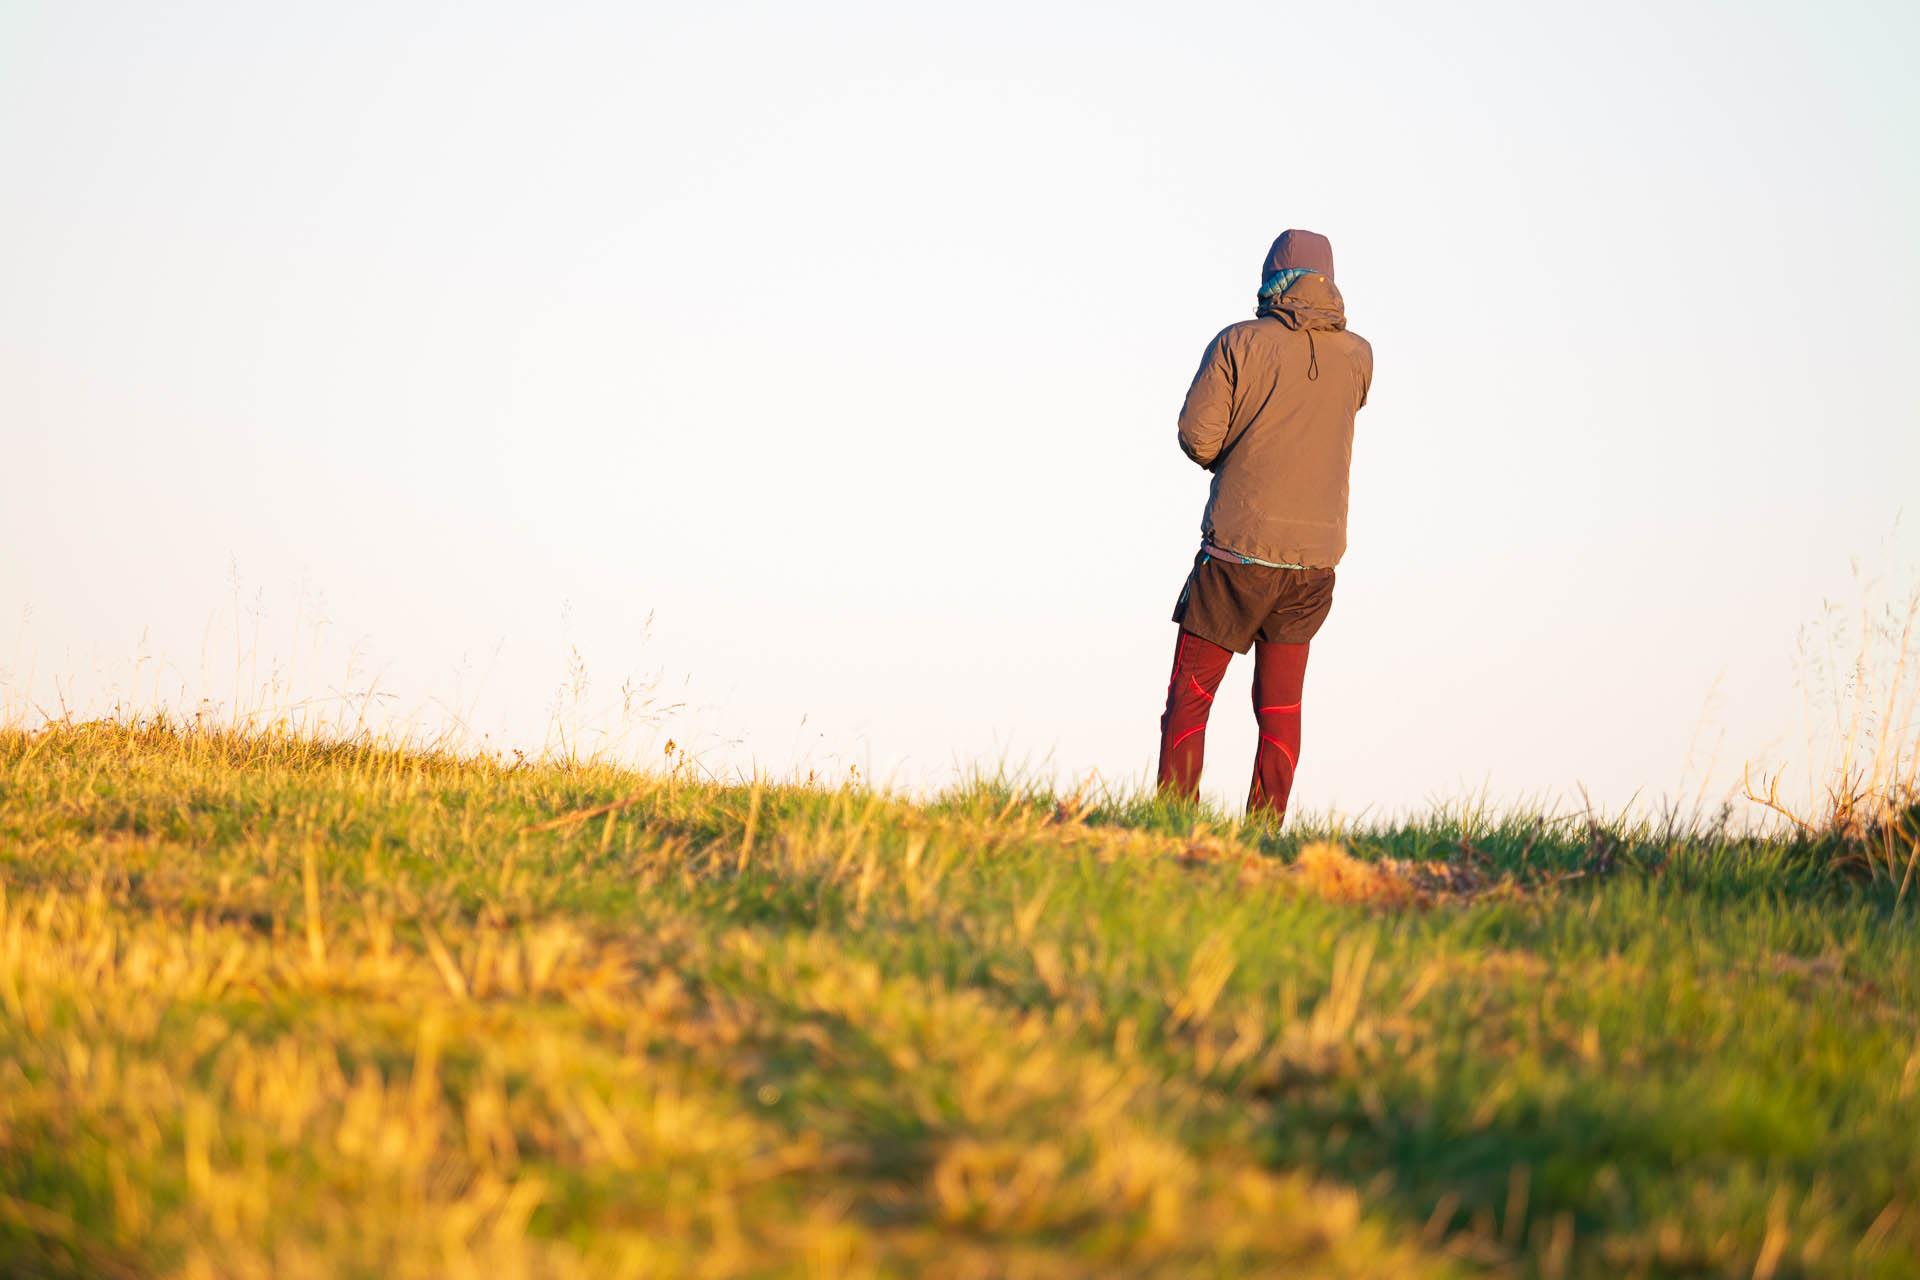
<box><xmin>0</xmin><ymin>0</ymin><xmax>1920</xmax><ymax>814</ymax></box>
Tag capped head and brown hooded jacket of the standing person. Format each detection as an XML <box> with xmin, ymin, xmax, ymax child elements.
<box><xmin>1179</xmin><ymin>230</ymin><xmax>1373</xmax><ymax>568</ymax></box>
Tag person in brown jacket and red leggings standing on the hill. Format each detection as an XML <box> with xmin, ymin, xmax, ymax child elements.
<box><xmin>1158</xmin><ymin>230</ymin><xmax>1373</xmax><ymax>821</ymax></box>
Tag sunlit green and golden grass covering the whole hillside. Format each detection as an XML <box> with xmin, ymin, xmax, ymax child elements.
<box><xmin>0</xmin><ymin>723</ymin><xmax>1920</xmax><ymax>1280</ymax></box>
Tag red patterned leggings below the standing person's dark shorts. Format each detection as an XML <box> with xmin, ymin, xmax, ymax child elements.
<box><xmin>1160</xmin><ymin>631</ymin><xmax>1308</xmax><ymax>818</ymax></box>
